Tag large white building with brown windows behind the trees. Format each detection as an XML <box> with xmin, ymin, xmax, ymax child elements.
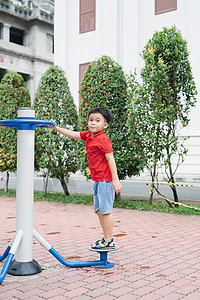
<box><xmin>54</xmin><ymin>0</ymin><xmax>200</xmax><ymax>180</ymax></box>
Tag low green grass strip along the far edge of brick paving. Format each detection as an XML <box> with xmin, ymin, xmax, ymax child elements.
<box><xmin>0</xmin><ymin>190</ymin><xmax>200</xmax><ymax>215</ymax></box>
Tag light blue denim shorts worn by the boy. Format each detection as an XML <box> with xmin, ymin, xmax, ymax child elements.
<box><xmin>94</xmin><ymin>179</ymin><xmax>115</xmax><ymax>215</ymax></box>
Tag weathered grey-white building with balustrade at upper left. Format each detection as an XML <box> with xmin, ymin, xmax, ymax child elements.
<box><xmin>0</xmin><ymin>0</ymin><xmax>54</xmax><ymax>100</ymax></box>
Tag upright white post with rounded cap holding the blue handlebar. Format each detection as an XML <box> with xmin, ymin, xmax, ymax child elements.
<box><xmin>15</xmin><ymin>108</ymin><xmax>35</xmax><ymax>262</ymax></box>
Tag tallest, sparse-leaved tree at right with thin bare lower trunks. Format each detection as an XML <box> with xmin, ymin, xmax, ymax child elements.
<box><xmin>129</xmin><ymin>26</ymin><xmax>196</xmax><ymax>202</ymax></box>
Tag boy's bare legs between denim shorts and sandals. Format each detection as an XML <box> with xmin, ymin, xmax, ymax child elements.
<box><xmin>96</xmin><ymin>210</ymin><xmax>113</xmax><ymax>241</ymax></box>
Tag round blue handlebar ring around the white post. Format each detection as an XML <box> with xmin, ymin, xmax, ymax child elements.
<box><xmin>0</xmin><ymin>118</ymin><xmax>55</xmax><ymax>130</ymax></box>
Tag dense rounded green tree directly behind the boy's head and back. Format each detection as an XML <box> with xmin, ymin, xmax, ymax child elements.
<box><xmin>78</xmin><ymin>56</ymin><xmax>140</xmax><ymax>200</ymax></box>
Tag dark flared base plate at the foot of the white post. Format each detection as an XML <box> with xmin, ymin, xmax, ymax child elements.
<box><xmin>8</xmin><ymin>259</ymin><xmax>42</xmax><ymax>276</ymax></box>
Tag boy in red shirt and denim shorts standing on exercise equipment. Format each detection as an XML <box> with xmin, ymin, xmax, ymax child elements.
<box><xmin>52</xmin><ymin>107</ymin><xmax>122</xmax><ymax>249</ymax></box>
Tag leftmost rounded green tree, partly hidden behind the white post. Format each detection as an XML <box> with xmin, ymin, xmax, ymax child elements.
<box><xmin>0</xmin><ymin>73</ymin><xmax>31</xmax><ymax>192</ymax></box>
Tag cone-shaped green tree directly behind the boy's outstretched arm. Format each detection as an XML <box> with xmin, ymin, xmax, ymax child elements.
<box><xmin>34</xmin><ymin>65</ymin><xmax>78</xmax><ymax>196</ymax></box>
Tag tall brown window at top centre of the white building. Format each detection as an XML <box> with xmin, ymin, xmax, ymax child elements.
<box><xmin>80</xmin><ymin>0</ymin><xmax>95</xmax><ymax>33</ymax></box>
